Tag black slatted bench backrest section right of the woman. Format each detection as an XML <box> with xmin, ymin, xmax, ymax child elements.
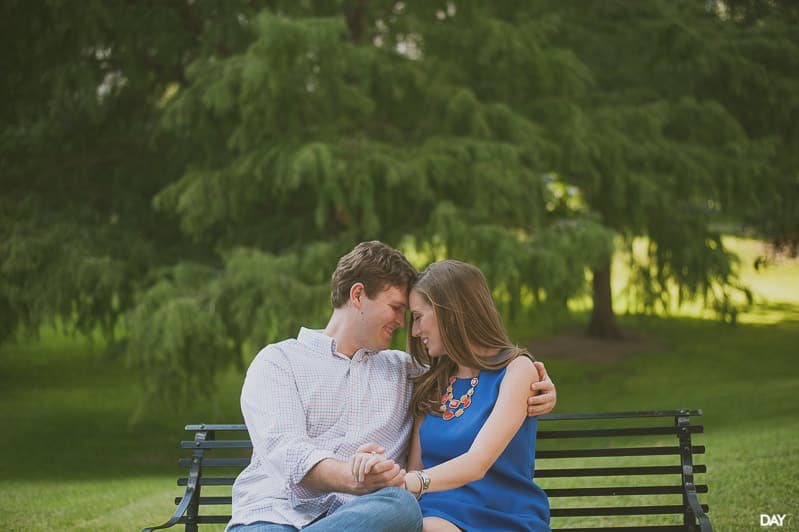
<box><xmin>535</xmin><ymin>410</ymin><xmax>712</xmax><ymax>531</ymax></box>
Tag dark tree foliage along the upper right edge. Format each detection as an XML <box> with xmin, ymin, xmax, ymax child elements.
<box><xmin>702</xmin><ymin>0</ymin><xmax>799</xmax><ymax>257</ymax></box>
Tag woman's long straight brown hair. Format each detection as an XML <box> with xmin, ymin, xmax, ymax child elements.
<box><xmin>408</xmin><ymin>260</ymin><xmax>532</xmax><ymax>416</ymax></box>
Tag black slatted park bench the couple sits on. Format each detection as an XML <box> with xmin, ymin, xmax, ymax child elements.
<box><xmin>144</xmin><ymin>410</ymin><xmax>712</xmax><ymax>532</ymax></box>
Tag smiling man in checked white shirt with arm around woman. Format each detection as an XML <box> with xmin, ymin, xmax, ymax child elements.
<box><xmin>228</xmin><ymin>241</ymin><xmax>556</xmax><ymax>532</ymax></box>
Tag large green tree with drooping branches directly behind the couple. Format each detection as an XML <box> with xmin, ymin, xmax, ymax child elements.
<box><xmin>130</xmin><ymin>2</ymin><xmax>610</xmax><ymax>396</ymax></box>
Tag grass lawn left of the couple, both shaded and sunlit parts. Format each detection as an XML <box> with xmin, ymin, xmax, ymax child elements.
<box><xmin>0</xmin><ymin>335</ymin><xmax>241</xmax><ymax>531</ymax></box>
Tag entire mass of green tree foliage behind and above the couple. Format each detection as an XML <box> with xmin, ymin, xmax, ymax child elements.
<box><xmin>0</xmin><ymin>0</ymin><xmax>799</xmax><ymax>394</ymax></box>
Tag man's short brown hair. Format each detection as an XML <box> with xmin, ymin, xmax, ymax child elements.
<box><xmin>330</xmin><ymin>240</ymin><xmax>417</xmax><ymax>308</ymax></box>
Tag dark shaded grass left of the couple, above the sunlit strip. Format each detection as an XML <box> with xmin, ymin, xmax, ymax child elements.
<box><xmin>0</xmin><ymin>339</ymin><xmax>241</xmax><ymax>481</ymax></box>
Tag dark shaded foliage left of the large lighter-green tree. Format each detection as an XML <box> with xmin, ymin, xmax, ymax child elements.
<box><xmin>0</xmin><ymin>0</ymin><xmax>262</xmax><ymax>339</ymax></box>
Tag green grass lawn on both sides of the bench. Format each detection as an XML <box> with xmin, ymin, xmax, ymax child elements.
<box><xmin>0</xmin><ymin>241</ymin><xmax>799</xmax><ymax>531</ymax></box>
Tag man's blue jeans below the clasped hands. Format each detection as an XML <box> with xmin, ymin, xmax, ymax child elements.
<box><xmin>230</xmin><ymin>488</ymin><xmax>422</xmax><ymax>532</ymax></box>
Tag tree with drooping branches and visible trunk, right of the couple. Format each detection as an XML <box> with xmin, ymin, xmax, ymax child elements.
<box><xmin>532</xmin><ymin>0</ymin><xmax>782</xmax><ymax>337</ymax></box>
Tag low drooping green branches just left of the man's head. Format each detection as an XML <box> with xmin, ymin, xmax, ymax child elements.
<box><xmin>126</xmin><ymin>245</ymin><xmax>335</xmax><ymax>415</ymax></box>
